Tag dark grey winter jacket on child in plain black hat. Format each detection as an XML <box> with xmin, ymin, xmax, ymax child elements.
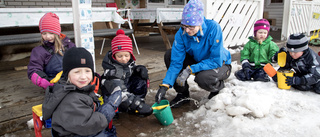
<box><xmin>42</xmin><ymin>81</ymin><xmax>111</xmax><ymax>136</ymax></box>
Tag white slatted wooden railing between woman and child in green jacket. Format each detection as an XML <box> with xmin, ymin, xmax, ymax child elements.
<box><xmin>202</xmin><ymin>0</ymin><xmax>264</xmax><ymax>48</ymax></box>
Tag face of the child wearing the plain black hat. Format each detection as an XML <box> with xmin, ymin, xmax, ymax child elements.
<box><xmin>68</xmin><ymin>67</ymin><xmax>92</xmax><ymax>88</ymax></box>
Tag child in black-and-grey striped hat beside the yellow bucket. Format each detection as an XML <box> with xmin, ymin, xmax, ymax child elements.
<box><xmin>272</xmin><ymin>34</ymin><xmax>320</xmax><ymax>94</ymax></box>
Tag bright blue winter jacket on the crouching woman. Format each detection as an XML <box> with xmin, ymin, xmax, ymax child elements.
<box><xmin>163</xmin><ymin>19</ymin><xmax>231</xmax><ymax>86</ymax></box>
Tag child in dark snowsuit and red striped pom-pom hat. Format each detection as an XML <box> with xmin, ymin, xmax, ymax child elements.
<box><xmin>101</xmin><ymin>29</ymin><xmax>153</xmax><ymax>116</ymax></box>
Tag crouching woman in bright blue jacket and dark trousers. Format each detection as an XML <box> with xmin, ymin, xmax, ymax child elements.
<box><xmin>155</xmin><ymin>0</ymin><xmax>231</xmax><ymax>107</ymax></box>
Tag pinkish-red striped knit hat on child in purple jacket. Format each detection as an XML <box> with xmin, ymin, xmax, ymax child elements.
<box><xmin>39</xmin><ymin>12</ymin><xmax>61</xmax><ymax>35</ymax></box>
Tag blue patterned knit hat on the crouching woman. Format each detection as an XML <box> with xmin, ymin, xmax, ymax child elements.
<box><xmin>181</xmin><ymin>0</ymin><xmax>203</xmax><ymax>26</ymax></box>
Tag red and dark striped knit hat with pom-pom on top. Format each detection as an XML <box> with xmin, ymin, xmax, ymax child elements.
<box><xmin>111</xmin><ymin>29</ymin><xmax>136</xmax><ymax>60</ymax></box>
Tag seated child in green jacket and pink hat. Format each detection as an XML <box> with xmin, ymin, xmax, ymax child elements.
<box><xmin>235</xmin><ymin>19</ymin><xmax>279</xmax><ymax>82</ymax></box>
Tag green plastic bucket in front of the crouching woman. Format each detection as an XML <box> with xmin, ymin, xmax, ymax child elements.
<box><xmin>152</xmin><ymin>100</ymin><xmax>173</xmax><ymax>126</ymax></box>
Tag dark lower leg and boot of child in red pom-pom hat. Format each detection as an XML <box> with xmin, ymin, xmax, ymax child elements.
<box><xmin>119</xmin><ymin>94</ymin><xmax>153</xmax><ymax>116</ymax></box>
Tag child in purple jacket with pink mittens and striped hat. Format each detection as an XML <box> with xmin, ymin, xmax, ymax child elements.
<box><xmin>28</xmin><ymin>12</ymin><xmax>75</xmax><ymax>89</ymax></box>
